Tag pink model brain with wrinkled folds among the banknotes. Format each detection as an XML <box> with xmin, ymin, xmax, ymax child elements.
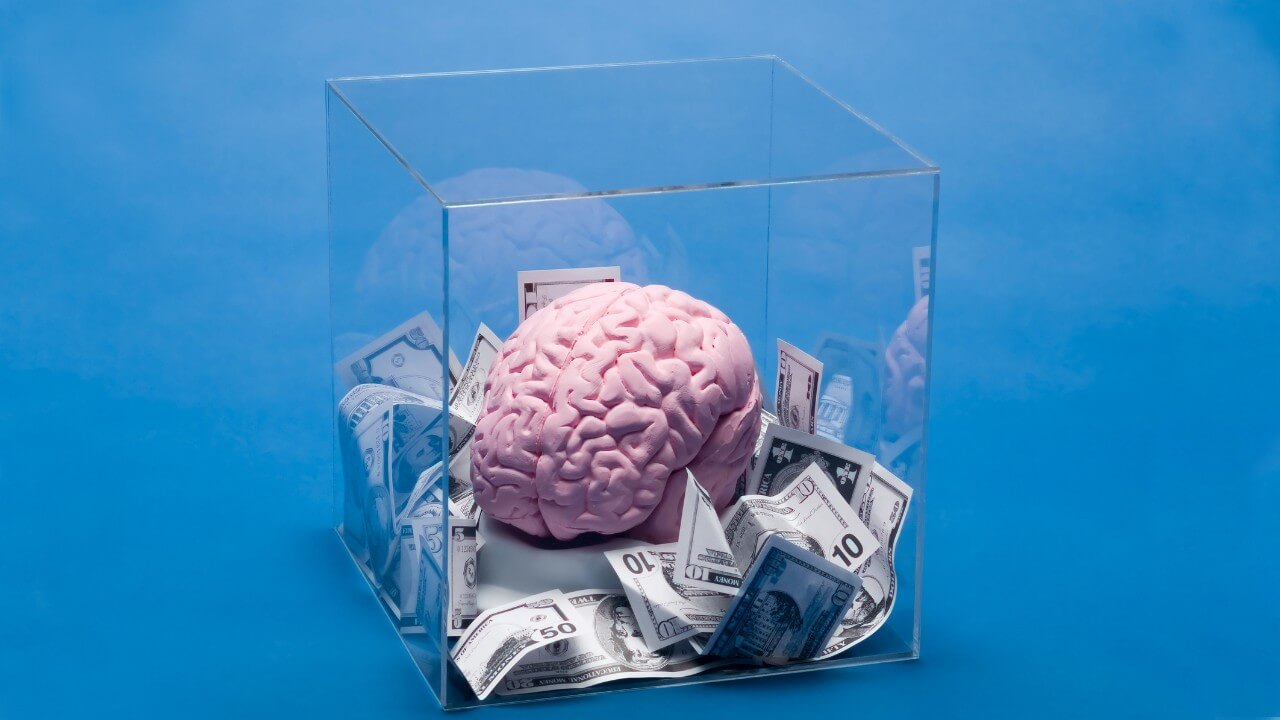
<box><xmin>471</xmin><ymin>283</ymin><xmax>760</xmax><ymax>542</ymax></box>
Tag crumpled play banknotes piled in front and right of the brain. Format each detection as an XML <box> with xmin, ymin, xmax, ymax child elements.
<box><xmin>452</xmin><ymin>438</ymin><xmax>911</xmax><ymax>700</ymax></box>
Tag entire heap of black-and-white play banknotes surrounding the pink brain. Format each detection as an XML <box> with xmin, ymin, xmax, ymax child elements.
<box><xmin>338</xmin><ymin>268</ymin><xmax>911</xmax><ymax>700</ymax></box>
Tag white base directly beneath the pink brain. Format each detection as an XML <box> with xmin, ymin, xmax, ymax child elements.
<box><xmin>476</xmin><ymin>515</ymin><xmax>649</xmax><ymax>612</ymax></box>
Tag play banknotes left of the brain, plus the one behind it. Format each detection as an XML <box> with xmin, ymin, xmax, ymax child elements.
<box><xmin>334</xmin><ymin>266</ymin><xmax>621</xmax><ymax>637</ymax></box>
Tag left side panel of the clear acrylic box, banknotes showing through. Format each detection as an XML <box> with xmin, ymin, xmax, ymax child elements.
<box><xmin>326</xmin><ymin>83</ymin><xmax>458</xmax><ymax>697</ymax></box>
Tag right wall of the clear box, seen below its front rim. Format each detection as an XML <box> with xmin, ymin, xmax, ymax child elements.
<box><xmin>763</xmin><ymin>174</ymin><xmax>936</xmax><ymax>655</ymax></box>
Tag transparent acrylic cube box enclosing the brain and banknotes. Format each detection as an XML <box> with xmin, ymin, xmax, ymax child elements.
<box><xmin>326</xmin><ymin>56</ymin><xmax>938</xmax><ymax>708</ymax></box>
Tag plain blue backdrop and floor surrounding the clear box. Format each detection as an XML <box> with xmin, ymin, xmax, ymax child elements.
<box><xmin>0</xmin><ymin>1</ymin><xmax>1280</xmax><ymax>717</ymax></box>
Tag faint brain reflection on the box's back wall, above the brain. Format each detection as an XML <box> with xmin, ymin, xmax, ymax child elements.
<box><xmin>356</xmin><ymin>168</ymin><xmax>654</xmax><ymax>337</ymax></box>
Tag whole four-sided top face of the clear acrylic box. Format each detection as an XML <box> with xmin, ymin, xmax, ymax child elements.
<box><xmin>328</xmin><ymin>56</ymin><xmax>938</xmax><ymax>208</ymax></box>
